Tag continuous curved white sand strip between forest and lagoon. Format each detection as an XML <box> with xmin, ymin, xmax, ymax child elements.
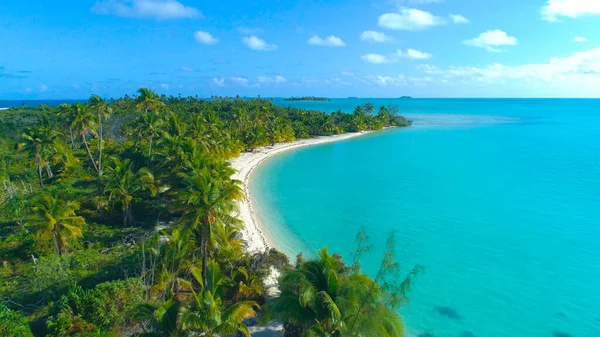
<box><xmin>230</xmin><ymin>131</ymin><xmax>370</xmax><ymax>253</ymax></box>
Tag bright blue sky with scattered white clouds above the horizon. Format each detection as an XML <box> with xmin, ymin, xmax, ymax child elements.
<box><xmin>0</xmin><ymin>0</ymin><xmax>600</xmax><ymax>99</ymax></box>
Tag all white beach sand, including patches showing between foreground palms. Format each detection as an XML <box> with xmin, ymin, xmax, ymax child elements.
<box><xmin>230</xmin><ymin>131</ymin><xmax>370</xmax><ymax>337</ymax></box>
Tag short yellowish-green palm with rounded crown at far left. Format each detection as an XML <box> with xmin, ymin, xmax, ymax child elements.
<box><xmin>32</xmin><ymin>192</ymin><xmax>85</xmax><ymax>255</ymax></box>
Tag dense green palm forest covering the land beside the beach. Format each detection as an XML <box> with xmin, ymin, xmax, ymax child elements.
<box><xmin>0</xmin><ymin>88</ymin><xmax>419</xmax><ymax>337</ymax></box>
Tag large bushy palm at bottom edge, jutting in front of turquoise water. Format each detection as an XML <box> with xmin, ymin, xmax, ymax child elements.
<box><xmin>267</xmin><ymin>248</ymin><xmax>410</xmax><ymax>337</ymax></box>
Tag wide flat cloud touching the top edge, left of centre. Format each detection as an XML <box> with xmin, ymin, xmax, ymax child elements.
<box><xmin>92</xmin><ymin>0</ymin><xmax>202</xmax><ymax>20</ymax></box>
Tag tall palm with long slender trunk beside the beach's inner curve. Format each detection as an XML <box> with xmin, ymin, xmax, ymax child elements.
<box><xmin>178</xmin><ymin>168</ymin><xmax>244</xmax><ymax>286</ymax></box>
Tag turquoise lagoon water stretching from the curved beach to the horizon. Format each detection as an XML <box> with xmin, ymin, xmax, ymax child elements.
<box><xmin>250</xmin><ymin>99</ymin><xmax>600</xmax><ymax>337</ymax></box>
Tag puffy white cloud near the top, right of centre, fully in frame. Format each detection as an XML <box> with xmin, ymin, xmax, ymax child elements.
<box><xmin>378</xmin><ymin>8</ymin><xmax>446</xmax><ymax>30</ymax></box>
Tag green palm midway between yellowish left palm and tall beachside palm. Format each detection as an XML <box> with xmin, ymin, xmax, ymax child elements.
<box><xmin>104</xmin><ymin>158</ymin><xmax>157</xmax><ymax>226</ymax></box>
